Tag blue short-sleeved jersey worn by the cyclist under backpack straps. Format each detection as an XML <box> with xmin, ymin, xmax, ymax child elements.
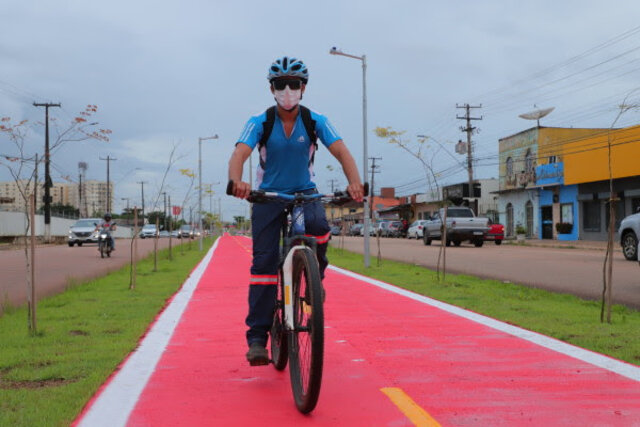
<box><xmin>238</xmin><ymin>107</ymin><xmax>342</xmax><ymax>194</ymax></box>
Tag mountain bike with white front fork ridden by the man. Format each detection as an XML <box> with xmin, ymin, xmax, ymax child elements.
<box><xmin>227</xmin><ymin>181</ymin><xmax>368</xmax><ymax>414</ymax></box>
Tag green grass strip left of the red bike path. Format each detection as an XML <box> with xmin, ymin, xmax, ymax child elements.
<box><xmin>0</xmin><ymin>240</ymin><xmax>211</xmax><ymax>426</ymax></box>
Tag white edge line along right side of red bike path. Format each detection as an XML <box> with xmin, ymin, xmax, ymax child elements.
<box><xmin>329</xmin><ymin>265</ymin><xmax>640</xmax><ymax>381</ymax></box>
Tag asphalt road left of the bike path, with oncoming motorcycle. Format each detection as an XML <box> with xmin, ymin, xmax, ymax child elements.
<box><xmin>0</xmin><ymin>238</ymin><xmax>190</xmax><ymax>314</ymax></box>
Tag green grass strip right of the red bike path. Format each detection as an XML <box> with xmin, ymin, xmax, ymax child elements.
<box><xmin>328</xmin><ymin>247</ymin><xmax>640</xmax><ymax>365</ymax></box>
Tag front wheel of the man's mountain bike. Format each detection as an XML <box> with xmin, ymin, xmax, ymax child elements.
<box><xmin>289</xmin><ymin>249</ymin><xmax>324</xmax><ymax>414</ymax></box>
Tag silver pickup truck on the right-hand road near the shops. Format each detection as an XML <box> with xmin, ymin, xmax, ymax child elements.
<box><xmin>422</xmin><ymin>206</ymin><xmax>489</xmax><ymax>248</ymax></box>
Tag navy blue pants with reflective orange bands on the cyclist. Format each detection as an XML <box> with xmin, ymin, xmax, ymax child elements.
<box><xmin>246</xmin><ymin>195</ymin><xmax>330</xmax><ymax>346</ymax></box>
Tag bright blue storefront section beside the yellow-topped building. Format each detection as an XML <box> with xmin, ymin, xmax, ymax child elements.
<box><xmin>536</xmin><ymin>163</ymin><xmax>580</xmax><ymax>240</ymax></box>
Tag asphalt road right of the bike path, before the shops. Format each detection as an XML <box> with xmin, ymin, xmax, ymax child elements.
<box><xmin>331</xmin><ymin>236</ymin><xmax>640</xmax><ymax>309</ymax></box>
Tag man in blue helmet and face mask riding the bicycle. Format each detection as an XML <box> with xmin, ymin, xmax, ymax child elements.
<box><xmin>229</xmin><ymin>56</ymin><xmax>364</xmax><ymax>365</ymax></box>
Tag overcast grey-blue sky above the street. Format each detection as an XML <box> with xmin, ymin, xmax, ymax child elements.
<box><xmin>0</xmin><ymin>0</ymin><xmax>640</xmax><ymax>219</ymax></box>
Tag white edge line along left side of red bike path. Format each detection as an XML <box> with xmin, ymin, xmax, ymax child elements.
<box><xmin>78</xmin><ymin>238</ymin><xmax>220</xmax><ymax>427</ymax></box>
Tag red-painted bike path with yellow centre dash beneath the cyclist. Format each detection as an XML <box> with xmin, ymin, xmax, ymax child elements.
<box><xmin>78</xmin><ymin>236</ymin><xmax>640</xmax><ymax>426</ymax></box>
